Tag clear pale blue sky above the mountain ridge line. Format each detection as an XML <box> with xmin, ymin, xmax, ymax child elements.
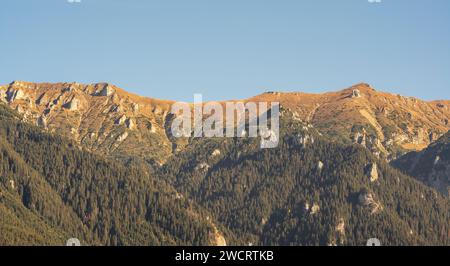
<box><xmin>0</xmin><ymin>0</ymin><xmax>450</xmax><ymax>101</ymax></box>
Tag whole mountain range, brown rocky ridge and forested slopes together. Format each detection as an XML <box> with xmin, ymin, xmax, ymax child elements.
<box><xmin>0</xmin><ymin>81</ymin><xmax>450</xmax><ymax>245</ymax></box>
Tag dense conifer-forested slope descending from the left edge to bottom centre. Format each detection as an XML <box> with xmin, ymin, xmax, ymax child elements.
<box><xmin>0</xmin><ymin>104</ymin><xmax>220</xmax><ymax>245</ymax></box>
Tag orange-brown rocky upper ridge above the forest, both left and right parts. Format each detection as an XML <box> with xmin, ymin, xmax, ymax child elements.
<box><xmin>0</xmin><ymin>81</ymin><xmax>450</xmax><ymax>163</ymax></box>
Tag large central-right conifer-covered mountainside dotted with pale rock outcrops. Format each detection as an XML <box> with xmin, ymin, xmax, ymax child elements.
<box><xmin>160</xmin><ymin>113</ymin><xmax>450</xmax><ymax>245</ymax></box>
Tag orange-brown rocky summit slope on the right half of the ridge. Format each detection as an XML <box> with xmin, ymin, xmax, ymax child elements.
<box><xmin>250</xmin><ymin>84</ymin><xmax>450</xmax><ymax>160</ymax></box>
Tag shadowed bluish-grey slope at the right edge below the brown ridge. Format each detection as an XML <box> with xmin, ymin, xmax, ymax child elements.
<box><xmin>392</xmin><ymin>132</ymin><xmax>450</xmax><ymax>196</ymax></box>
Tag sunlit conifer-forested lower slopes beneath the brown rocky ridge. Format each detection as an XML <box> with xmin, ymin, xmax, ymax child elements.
<box><xmin>0</xmin><ymin>101</ymin><xmax>450</xmax><ymax>245</ymax></box>
